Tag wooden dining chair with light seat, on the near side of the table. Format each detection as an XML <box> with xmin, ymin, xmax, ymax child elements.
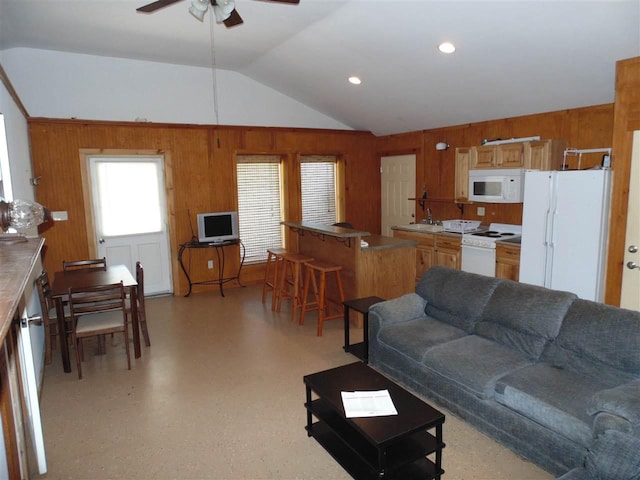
<box><xmin>69</xmin><ymin>282</ymin><xmax>131</xmax><ymax>379</ymax></box>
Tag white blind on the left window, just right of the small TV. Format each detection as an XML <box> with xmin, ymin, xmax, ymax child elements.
<box><xmin>237</xmin><ymin>155</ymin><xmax>283</xmax><ymax>263</ymax></box>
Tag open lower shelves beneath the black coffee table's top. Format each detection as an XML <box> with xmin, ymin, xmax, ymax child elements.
<box><xmin>305</xmin><ymin>399</ymin><xmax>444</xmax><ymax>480</ymax></box>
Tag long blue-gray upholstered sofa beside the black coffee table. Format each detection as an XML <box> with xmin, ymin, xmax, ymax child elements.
<box><xmin>369</xmin><ymin>267</ymin><xmax>640</xmax><ymax>480</ymax></box>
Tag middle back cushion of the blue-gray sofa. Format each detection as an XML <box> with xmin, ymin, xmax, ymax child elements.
<box><xmin>475</xmin><ymin>280</ymin><xmax>577</xmax><ymax>360</ymax></box>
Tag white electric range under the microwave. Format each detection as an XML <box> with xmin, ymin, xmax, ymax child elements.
<box><xmin>461</xmin><ymin>223</ymin><xmax>522</xmax><ymax>277</ymax></box>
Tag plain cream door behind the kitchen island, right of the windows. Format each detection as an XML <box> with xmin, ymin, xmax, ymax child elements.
<box><xmin>380</xmin><ymin>154</ymin><xmax>416</xmax><ymax>237</ymax></box>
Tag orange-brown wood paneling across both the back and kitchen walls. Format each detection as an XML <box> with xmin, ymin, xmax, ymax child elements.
<box><xmin>29</xmin><ymin>99</ymin><xmax>619</xmax><ymax>300</ymax></box>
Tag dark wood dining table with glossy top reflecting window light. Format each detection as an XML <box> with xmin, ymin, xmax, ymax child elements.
<box><xmin>51</xmin><ymin>265</ymin><xmax>142</xmax><ymax>373</ymax></box>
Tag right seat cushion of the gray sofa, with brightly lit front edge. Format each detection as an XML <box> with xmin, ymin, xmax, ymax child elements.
<box><xmin>495</xmin><ymin>363</ymin><xmax>602</xmax><ymax>447</ymax></box>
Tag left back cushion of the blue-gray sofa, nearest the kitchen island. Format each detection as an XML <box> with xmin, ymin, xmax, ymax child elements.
<box><xmin>416</xmin><ymin>266</ymin><xmax>501</xmax><ymax>333</ymax></box>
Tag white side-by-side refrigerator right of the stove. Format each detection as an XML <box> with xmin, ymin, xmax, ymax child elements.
<box><xmin>520</xmin><ymin>170</ymin><xmax>611</xmax><ymax>302</ymax></box>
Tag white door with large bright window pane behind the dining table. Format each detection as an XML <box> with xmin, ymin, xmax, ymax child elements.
<box><xmin>89</xmin><ymin>155</ymin><xmax>172</xmax><ymax>295</ymax></box>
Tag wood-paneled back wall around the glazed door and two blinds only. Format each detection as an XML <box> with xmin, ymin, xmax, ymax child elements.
<box><xmin>29</xmin><ymin>118</ymin><xmax>380</xmax><ymax>294</ymax></box>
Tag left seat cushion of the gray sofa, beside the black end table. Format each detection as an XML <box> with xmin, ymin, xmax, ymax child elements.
<box><xmin>378</xmin><ymin>317</ymin><xmax>467</xmax><ymax>362</ymax></box>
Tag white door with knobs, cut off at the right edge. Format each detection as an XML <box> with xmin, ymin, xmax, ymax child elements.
<box><xmin>620</xmin><ymin>130</ymin><xmax>640</xmax><ymax>310</ymax></box>
